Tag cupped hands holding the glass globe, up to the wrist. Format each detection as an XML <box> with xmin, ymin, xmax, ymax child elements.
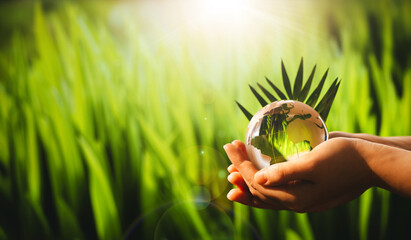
<box><xmin>224</xmin><ymin>138</ymin><xmax>378</xmax><ymax>212</ymax></box>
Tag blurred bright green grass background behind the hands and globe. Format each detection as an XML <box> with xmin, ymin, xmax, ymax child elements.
<box><xmin>0</xmin><ymin>0</ymin><xmax>411</xmax><ymax>239</ymax></box>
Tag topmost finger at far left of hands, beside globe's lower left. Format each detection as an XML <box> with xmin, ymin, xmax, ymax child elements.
<box><xmin>224</xmin><ymin>143</ymin><xmax>258</xmax><ymax>186</ymax></box>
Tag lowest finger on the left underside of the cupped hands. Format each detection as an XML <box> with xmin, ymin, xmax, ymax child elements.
<box><xmin>227</xmin><ymin>188</ymin><xmax>286</xmax><ymax>210</ymax></box>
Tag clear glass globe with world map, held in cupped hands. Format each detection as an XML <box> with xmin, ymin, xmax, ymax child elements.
<box><xmin>245</xmin><ymin>100</ymin><xmax>328</xmax><ymax>169</ymax></box>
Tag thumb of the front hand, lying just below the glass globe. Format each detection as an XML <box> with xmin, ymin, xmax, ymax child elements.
<box><xmin>254</xmin><ymin>159</ymin><xmax>313</xmax><ymax>185</ymax></box>
